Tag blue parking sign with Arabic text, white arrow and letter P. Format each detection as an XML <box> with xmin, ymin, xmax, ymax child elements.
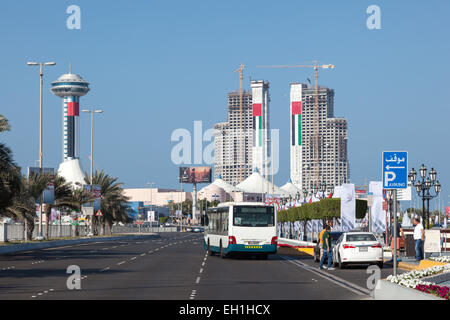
<box><xmin>382</xmin><ymin>151</ymin><xmax>408</xmax><ymax>189</ymax></box>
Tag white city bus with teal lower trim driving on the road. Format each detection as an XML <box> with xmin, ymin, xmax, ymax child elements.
<box><xmin>204</xmin><ymin>202</ymin><xmax>278</xmax><ymax>259</ymax></box>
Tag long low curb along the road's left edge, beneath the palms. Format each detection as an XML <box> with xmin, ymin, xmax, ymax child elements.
<box><xmin>0</xmin><ymin>233</ymin><xmax>160</xmax><ymax>254</ymax></box>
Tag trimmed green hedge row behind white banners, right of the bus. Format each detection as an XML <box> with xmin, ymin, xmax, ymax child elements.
<box><xmin>278</xmin><ymin>198</ymin><xmax>367</xmax><ymax>222</ymax></box>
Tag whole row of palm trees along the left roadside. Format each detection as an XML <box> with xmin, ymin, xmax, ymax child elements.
<box><xmin>0</xmin><ymin>115</ymin><xmax>130</xmax><ymax>240</ymax></box>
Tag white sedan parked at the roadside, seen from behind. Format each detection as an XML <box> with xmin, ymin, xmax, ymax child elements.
<box><xmin>333</xmin><ymin>232</ymin><xmax>383</xmax><ymax>269</ymax></box>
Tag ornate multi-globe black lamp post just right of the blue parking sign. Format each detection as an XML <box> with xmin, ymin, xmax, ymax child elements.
<box><xmin>408</xmin><ymin>164</ymin><xmax>441</xmax><ymax>229</ymax></box>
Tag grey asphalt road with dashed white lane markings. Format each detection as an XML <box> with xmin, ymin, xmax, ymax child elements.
<box><xmin>0</xmin><ymin>233</ymin><xmax>400</xmax><ymax>300</ymax></box>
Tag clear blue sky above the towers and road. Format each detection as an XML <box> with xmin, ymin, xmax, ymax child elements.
<box><xmin>0</xmin><ymin>0</ymin><xmax>450</xmax><ymax>211</ymax></box>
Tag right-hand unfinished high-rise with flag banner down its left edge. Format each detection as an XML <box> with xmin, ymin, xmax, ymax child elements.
<box><xmin>290</xmin><ymin>83</ymin><xmax>349</xmax><ymax>191</ymax></box>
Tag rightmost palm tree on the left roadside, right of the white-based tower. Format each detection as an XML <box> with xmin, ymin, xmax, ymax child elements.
<box><xmin>92</xmin><ymin>170</ymin><xmax>130</xmax><ymax>235</ymax></box>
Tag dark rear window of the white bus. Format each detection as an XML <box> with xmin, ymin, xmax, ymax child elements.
<box><xmin>233</xmin><ymin>206</ymin><xmax>275</xmax><ymax>227</ymax></box>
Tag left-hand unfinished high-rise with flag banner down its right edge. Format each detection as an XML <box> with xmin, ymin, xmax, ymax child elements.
<box><xmin>214</xmin><ymin>81</ymin><xmax>270</xmax><ymax>185</ymax></box>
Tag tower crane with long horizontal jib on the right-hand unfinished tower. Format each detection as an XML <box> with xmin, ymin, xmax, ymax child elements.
<box><xmin>257</xmin><ymin>60</ymin><xmax>336</xmax><ymax>185</ymax></box>
